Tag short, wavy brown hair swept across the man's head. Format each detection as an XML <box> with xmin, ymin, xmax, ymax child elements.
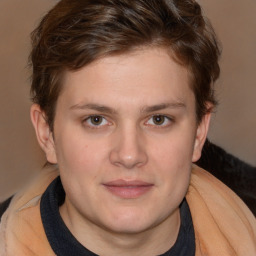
<box><xmin>30</xmin><ymin>0</ymin><xmax>220</xmax><ymax>129</ymax></box>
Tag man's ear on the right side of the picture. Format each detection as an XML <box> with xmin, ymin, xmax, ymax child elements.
<box><xmin>192</xmin><ymin>112</ymin><xmax>211</xmax><ymax>162</ymax></box>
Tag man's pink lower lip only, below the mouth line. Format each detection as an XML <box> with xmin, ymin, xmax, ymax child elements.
<box><xmin>105</xmin><ymin>185</ymin><xmax>153</xmax><ymax>199</ymax></box>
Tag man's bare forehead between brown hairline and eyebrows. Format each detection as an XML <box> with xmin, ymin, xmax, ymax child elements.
<box><xmin>60</xmin><ymin>48</ymin><xmax>193</xmax><ymax>111</ymax></box>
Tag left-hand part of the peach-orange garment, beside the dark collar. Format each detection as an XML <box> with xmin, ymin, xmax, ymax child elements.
<box><xmin>0</xmin><ymin>166</ymin><xmax>58</xmax><ymax>256</ymax></box>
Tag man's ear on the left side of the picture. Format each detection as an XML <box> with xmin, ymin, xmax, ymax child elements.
<box><xmin>30</xmin><ymin>104</ymin><xmax>57</xmax><ymax>164</ymax></box>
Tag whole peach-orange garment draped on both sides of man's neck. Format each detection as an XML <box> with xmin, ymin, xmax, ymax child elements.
<box><xmin>0</xmin><ymin>166</ymin><xmax>256</xmax><ymax>256</ymax></box>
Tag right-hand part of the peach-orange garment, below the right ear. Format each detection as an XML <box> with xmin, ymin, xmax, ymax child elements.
<box><xmin>186</xmin><ymin>166</ymin><xmax>256</xmax><ymax>256</ymax></box>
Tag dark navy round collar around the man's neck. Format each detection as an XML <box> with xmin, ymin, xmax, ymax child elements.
<box><xmin>40</xmin><ymin>177</ymin><xmax>195</xmax><ymax>256</ymax></box>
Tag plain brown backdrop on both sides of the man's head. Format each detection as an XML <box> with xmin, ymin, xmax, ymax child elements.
<box><xmin>0</xmin><ymin>0</ymin><xmax>256</xmax><ymax>200</ymax></box>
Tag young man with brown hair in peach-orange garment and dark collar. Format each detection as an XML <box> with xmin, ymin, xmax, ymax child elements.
<box><xmin>0</xmin><ymin>0</ymin><xmax>256</xmax><ymax>256</ymax></box>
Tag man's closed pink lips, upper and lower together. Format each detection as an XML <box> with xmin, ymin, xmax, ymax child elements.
<box><xmin>103</xmin><ymin>179</ymin><xmax>154</xmax><ymax>199</ymax></box>
